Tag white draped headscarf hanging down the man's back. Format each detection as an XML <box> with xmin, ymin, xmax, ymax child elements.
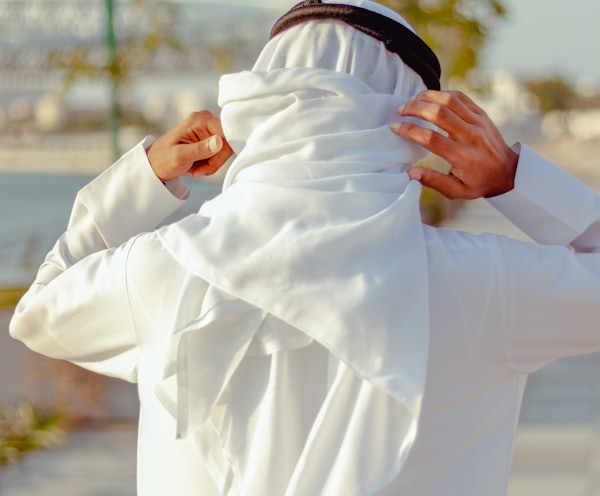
<box><xmin>157</xmin><ymin>1</ymin><xmax>429</xmax><ymax>496</ymax></box>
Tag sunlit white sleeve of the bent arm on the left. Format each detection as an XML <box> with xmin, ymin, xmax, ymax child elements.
<box><xmin>10</xmin><ymin>140</ymin><xmax>188</xmax><ymax>381</ymax></box>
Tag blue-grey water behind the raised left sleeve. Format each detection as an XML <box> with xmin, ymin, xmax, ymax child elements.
<box><xmin>0</xmin><ymin>172</ymin><xmax>221</xmax><ymax>286</ymax></box>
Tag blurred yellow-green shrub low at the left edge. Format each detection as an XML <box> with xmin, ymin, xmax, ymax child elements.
<box><xmin>0</xmin><ymin>403</ymin><xmax>64</xmax><ymax>467</ymax></box>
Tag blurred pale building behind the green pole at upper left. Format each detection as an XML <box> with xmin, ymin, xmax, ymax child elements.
<box><xmin>0</xmin><ymin>0</ymin><xmax>274</xmax><ymax>137</ymax></box>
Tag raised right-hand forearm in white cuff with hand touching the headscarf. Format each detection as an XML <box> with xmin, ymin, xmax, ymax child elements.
<box><xmin>392</xmin><ymin>91</ymin><xmax>600</xmax><ymax>252</ymax></box>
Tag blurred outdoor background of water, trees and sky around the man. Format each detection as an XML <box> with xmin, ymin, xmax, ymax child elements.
<box><xmin>0</xmin><ymin>0</ymin><xmax>600</xmax><ymax>496</ymax></box>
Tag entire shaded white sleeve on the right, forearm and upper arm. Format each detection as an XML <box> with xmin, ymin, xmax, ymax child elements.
<box><xmin>480</xmin><ymin>145</ymin><xmax>600</xmax><ymax>372</ymax></box>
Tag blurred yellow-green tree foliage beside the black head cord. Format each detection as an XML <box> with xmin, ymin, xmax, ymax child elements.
<box><xmin>381</xmin><ymin>0</ymin><xmax>507</xmax><ymax>81</ymax></box>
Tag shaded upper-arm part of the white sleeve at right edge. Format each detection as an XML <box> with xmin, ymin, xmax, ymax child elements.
<box><xmin>499</xmin><ymin>238</ymin><xmax>600</xmax><ymax>373</ymax></box>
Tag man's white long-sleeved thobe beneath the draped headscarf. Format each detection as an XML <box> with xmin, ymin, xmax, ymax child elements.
<box><xmin>10</xmin><ymin>143</ymin><xmax>600</xmax><ymax>496</ymax></box>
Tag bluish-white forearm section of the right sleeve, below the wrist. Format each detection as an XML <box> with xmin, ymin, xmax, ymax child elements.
<box><xmin>488</xmin><ymin>145</ymin><xmax>600</xmax><ymax>252</ymax></box>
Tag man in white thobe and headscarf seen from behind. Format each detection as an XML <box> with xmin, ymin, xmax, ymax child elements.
<box><xmin>11</xmin><ymin>0</ymin><xmax>600</xmax><ymax>496</ymax></box>
